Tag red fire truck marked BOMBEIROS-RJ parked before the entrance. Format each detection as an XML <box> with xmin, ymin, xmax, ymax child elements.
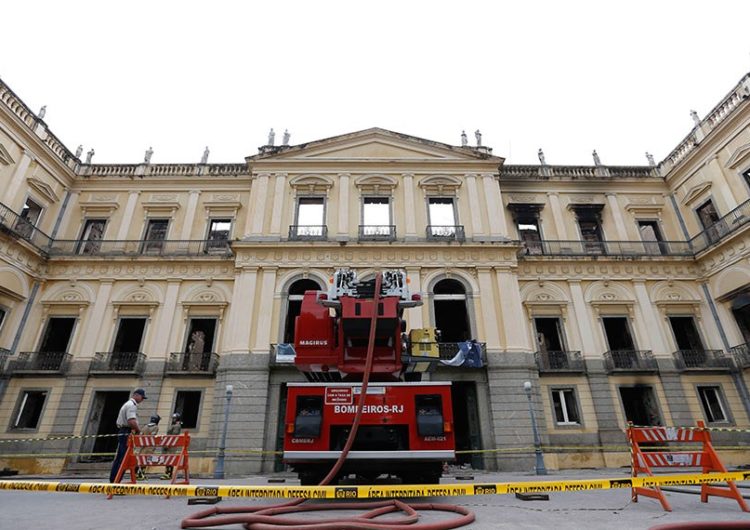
<box><xmin>283</xmin><ymin>269</ymin><xmax>455</xmax><ymax>485</ymax></box>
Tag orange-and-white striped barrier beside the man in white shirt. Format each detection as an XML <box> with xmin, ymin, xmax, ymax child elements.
<box><xmin>108</xmin><ymin>433</ymin><xmax>190</xmax><ymax>499</ymax></box>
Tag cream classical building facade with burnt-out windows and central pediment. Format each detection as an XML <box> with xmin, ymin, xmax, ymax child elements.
<box><xmin>0</xmin><ymin>75</ymin><xmax>750</xmax><ymax>474</ymax></box>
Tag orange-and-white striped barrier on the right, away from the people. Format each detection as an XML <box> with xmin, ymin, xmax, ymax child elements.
<box><xmin>628</xmin><ymin>421</ymin><xmax>750</xmax><ymax>512</ymax></box>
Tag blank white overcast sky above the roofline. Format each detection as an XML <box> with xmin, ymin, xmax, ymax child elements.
<box><xmin>0</xmin><ymin>0</ymin><xmax>750</xmax><ymax>165</ymax></box>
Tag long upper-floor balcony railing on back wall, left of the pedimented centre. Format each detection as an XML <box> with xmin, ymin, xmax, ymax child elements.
<box><xmin>47</xmin><ymin>239</ymin><xmax>232</xmax><ymax>257</ymax></box>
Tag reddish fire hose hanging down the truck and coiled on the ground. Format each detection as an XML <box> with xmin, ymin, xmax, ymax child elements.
<box><xmin>182</xmin><ymin>273</ymin><xmax>475</xmax><ymax>530</ymax></box>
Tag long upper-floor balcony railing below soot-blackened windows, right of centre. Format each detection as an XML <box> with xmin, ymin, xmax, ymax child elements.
<box><xmin>520</xmin><ymin>240</ymin><xmax>693</xmax><ymax>257</ymax></box>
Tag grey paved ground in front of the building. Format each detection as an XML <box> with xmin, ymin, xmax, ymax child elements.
<box><xmin>0</xmin><ymin>469</ymin><xmax>750</xmax><ymax>530</ymax></box>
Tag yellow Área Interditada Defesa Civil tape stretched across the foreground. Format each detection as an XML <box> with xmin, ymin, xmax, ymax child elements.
<box><xmin>0</xmin><ymin>472</ymin><xmax>750</xmax><ymax>499</ymax></box>
